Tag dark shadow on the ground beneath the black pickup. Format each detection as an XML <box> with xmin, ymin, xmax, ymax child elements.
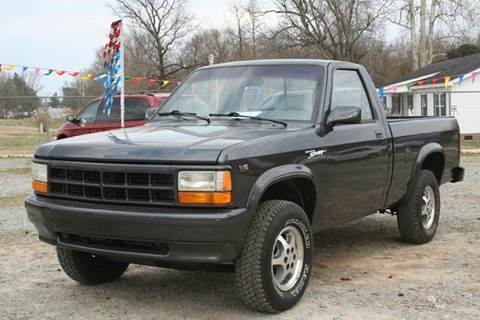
<box><xmin>62</xmin><ymin>216</ymin><xmax>403</xmax><ymax>315</ymax></box>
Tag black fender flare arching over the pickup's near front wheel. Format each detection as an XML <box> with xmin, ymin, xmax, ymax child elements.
<box><xmin>246</xmin><ymin>164</ymin><xmax>317</xmax><ymax>226</ymax></box>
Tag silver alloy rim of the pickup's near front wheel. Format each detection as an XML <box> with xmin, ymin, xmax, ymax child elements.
<box><xmin>272</xmin><ymin>226</ymin><xmax>304</xmax><ymax>291</ymax></box>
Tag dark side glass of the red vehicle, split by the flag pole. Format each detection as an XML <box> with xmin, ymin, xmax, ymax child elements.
<box><xmin>98</xmin><ymin>98</ymin><xmax>149</xmax><ymax>122</ymax></box>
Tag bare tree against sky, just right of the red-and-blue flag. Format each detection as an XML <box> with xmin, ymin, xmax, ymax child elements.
<box><xmin>112</xmin><ymin>0</ymin><xmax>192</xmax><ymax>79</ymax></box>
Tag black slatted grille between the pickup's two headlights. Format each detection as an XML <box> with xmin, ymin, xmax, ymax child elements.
<box><xmin>48</xmin><ymin>167</ymin><xmax>176</xmax><ymax>204</ymax></box>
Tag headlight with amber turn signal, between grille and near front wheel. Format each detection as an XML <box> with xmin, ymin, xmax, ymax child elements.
<box><xmin>178</xmin><ymin>171</ymin><xmax>232</xmax><ymax>205</ymax></box>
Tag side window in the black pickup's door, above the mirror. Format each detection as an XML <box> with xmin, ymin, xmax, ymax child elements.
<box><xmin>330</xmin><ymin>70</ymin><xmax>373</xmax><ymax>120</ymax></box>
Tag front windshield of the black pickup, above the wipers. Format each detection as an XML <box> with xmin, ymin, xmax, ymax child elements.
<box><xmin>161</xmin><ymin>65</ymin><xmax>323</xmax><ymax>120</ymax></box>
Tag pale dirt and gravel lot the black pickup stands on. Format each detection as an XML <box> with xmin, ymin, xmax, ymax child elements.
<box><xmin>0</xmin><ymin>156</ymin><xmax>480</xmax><ymax>320</ymax></box>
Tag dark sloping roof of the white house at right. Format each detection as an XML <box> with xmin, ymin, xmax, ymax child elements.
<box><xmin>390</xmin><ymin>53</ymin><xmax>480</xmax><ymax>85</ymax></box>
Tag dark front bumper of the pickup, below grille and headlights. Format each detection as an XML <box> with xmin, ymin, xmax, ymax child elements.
<box><xmin>25</xmin><ymin>195</ymin><xmax>250</xmax><ymax>265</ymax></box>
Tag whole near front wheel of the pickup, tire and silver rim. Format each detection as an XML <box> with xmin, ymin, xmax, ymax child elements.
<box><xmin>235</xmin><ymin>200</ymin><xmax>313</xmax><ymax>313</ymax></box>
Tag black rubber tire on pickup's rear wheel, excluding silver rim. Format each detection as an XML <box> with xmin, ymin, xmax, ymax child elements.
<box><xmin>397</xmin><ymin>170</ymin><xmax>440</xmax><ymax>244</ymax></box>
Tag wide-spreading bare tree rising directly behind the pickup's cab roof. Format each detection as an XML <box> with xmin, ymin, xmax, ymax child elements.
<box><xmin>267</xmin><ymin>0</ymin><xmax>391</xmax><ymax>62</ymax></box>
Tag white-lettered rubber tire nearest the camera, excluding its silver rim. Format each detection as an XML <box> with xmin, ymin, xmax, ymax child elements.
<box><xmin>235</xmin><ymin>200</ymin><xmax>313</xmax><ymax>313</ymax></box>
